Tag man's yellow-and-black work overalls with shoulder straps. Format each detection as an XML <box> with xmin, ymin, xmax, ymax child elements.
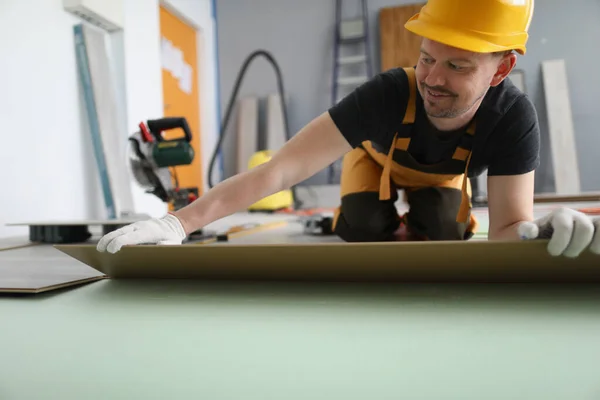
<box><xmin>332</xmin><ymin>68</ymin><xmax>478</xmax><ymax>242</ymax></box>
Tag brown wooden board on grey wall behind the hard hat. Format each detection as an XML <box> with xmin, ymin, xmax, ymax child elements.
<box><xmin>379</xmin><ymin>3</ymin><xmax>424</xmax><ymax>71</ymax></box>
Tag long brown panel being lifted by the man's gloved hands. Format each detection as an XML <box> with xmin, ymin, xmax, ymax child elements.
<box><xmin>55</xmin><ymin>240</ymin><xmax>600</xmax><ymax>283</ymax></box>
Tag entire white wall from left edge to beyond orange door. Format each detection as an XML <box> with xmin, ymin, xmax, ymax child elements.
<box><xmin>0</xmin><ymin>0</ymin><xmax>218</xmax><ymax>237</ymax></box>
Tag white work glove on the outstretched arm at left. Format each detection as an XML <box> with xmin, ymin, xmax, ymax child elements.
<box><xmin>96</xmin><ymin>214</ymin><xmax>187</xmax><ymax>253</ymax></box>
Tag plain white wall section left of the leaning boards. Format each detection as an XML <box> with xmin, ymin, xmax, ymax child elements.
<box><xmin>0</xmin><ymin>0</ymin><xmax>96</xmax><ymax>236</ymax></box>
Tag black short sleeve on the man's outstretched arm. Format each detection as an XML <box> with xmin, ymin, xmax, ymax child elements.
<box><xmin>329</xmin><ymin>68</ymin><xmax>409</xmax><ymax>148</ymax></box>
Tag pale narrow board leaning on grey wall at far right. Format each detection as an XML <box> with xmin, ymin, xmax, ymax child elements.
<box><xmin>542</xmin><ymin>59</ymin><xmax>581</xmax><ymax>194</ymax></box>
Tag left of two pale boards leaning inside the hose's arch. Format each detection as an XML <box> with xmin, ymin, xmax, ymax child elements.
<box><xmin>236</xmin><ymin>96</ymin><xmax>258</xmax><ymax>174</ymax></box>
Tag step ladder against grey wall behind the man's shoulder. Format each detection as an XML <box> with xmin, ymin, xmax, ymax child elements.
<box><xmin>327</xmin><ymin>0</ymin><xmax>373</xmax><ymax>184</ymax></box>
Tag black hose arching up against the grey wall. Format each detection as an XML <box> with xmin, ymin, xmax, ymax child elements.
<box><xmin>208</xmin><ymin>50</ymin><xmax>300</xmax><ymax>209</ymax></box>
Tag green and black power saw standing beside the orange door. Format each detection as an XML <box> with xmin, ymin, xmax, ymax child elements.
<box><xmin>129</xmin><ymin>117</ymin><xmax>198</xmax><ymax>209</ymax></box>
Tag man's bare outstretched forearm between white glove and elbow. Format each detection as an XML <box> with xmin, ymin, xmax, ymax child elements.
<box><xmin>174</xmin><ymin>163</ymin><xmax>282</xmax><ymax>234</ymax></box>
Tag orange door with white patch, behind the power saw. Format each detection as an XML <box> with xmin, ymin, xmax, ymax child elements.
<box><xmin>160</xmin><ymin>6</ymin><xmax>203</xmax><ymax>195</ymax></box>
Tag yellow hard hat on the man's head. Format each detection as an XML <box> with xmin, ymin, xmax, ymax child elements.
<box><xmin>404</xmin><ymin>0</ymin><xmax>534</xmax><ymax>54</ymax></box>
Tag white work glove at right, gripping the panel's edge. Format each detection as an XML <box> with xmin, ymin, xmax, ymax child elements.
<box><xmin>518</xmin><ymin>208</ymin><xmax>600</xmax><ymax>261</ymax></box>
